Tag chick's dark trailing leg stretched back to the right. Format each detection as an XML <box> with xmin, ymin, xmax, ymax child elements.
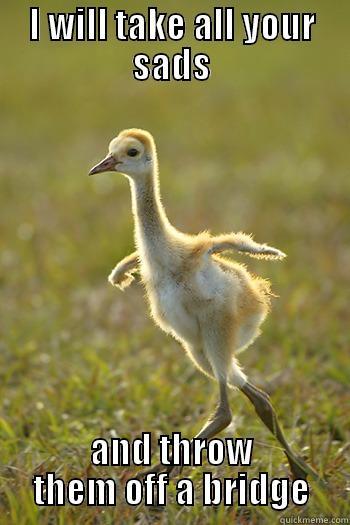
<box><xmin>241</xmin><ymin>381</ymin><xmax>324</xmax><ymax>483</ymax></box>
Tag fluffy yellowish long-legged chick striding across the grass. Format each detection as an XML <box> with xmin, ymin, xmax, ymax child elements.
<box><xmin>89</xmin><ymin>129</ymin><xmax>318</xmax><ymax>478</ymax></box>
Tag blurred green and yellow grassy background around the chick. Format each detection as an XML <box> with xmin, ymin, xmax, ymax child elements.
<box><xmin>0</xmin><ymin>0</ymin><xmax>350</xmax><ymax>525</ymax></box>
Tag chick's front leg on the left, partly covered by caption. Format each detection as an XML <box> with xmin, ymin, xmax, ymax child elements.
<box><xmin>136</xmin><ymin>381</ymin><xmax>232</xmax><ymax>478</ymax></box>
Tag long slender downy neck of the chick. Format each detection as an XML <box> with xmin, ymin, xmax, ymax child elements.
<box><xmin>130</xmin><ymin>168</ymin><xmax>172</xmax><ymax>253</ymax></box>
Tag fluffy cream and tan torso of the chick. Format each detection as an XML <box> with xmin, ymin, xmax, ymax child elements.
<box><xmin>138</xmin><ymin>229</ymin><xmax>269</xmax><ymax>385</ymax></box>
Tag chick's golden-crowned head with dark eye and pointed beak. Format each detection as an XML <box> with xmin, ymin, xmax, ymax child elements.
<box><xmin>89</xmin><ymin>129</ymin><xmax>156</xmax><ymax>180</ymax></box>
